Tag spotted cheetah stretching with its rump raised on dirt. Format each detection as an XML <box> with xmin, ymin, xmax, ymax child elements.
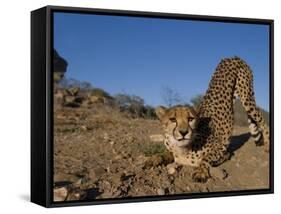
<box><xmin>155</xmin><ymin>57</ymin><xmax>269</xmax><ymax>182</ymax></box>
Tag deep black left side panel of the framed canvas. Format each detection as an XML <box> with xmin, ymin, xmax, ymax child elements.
<box><xmin>30</xmin><ymin>8</ymin><xmax>48</xmax><ymax>206</ymax></box>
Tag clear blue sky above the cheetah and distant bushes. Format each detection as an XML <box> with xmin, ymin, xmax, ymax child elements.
<box><xmin>54</xmin><ymin>12</ymin><xmax>269</xmax><ymax>110</ymax></box>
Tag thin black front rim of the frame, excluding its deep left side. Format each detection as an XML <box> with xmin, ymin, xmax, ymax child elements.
<box><xmin>31</xmin><ymin>6</ymin><xmax>274</xmax><ymax>207</ymax></box>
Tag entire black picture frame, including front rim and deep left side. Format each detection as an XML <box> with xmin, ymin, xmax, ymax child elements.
<box><xmin>31</xmin><ymin>6</ymin><xmax>274</xmax><ymax>207</ymax></box>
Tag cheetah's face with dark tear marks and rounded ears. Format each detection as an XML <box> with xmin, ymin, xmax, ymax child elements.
<box><xmin>156</xmin><ymin>106</ymin><xmax>197</xmax><ymax>147</ymax></box>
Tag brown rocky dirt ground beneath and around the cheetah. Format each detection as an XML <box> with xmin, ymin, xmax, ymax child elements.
<box><xmin>54</xmin><ymin>105</ymin><xmax>269</xmax><ymax>200</ymax></box>
